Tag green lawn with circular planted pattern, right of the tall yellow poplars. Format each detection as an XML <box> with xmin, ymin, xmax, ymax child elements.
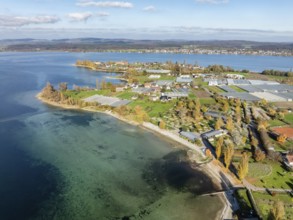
<box><xmin>247</xmin><ymin>160</ymin><xmax>293</xmax><ymax>189</ymax></box>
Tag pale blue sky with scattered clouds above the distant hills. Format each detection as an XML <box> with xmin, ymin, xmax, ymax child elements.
<box><xmin>0</xmin><ymin>0</ymin><xmax>293</xmax><ymax>42</ymax></box>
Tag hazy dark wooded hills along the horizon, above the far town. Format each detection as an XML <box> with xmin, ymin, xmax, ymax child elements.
<box><xmin>0</xmin><ymin>38</ymin><xmax>293</xmax><ymax>52</ymax></box>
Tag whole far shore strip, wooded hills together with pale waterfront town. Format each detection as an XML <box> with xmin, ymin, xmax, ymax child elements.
<box><xmin>0</xmin><ymin>38</ymin><xmax>293</xmax><ymax>56</ymax></box>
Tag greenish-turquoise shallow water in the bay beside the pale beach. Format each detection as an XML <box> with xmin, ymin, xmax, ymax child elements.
<box><xmin>17</xmin><ymin>106</ymin><xmax>223</xmax><ymax>219</ymax></box>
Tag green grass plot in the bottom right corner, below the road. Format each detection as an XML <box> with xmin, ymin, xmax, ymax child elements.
<box><xmin>252</xmin><ymin>192</ymin><xmax>293</xmax><ymax>220</ymax></box>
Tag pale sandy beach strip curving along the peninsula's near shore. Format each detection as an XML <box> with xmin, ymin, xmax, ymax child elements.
<box><xmin>36</xmin><ymin>93</ymin><xmax>237</xmax><ymax>218</ymax></box>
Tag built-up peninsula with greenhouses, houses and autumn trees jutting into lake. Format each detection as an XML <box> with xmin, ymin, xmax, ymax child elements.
<box><xmin>40</xmin><ymin>60</ymin><xmax>293</xmax><ymax>219</ymax></box>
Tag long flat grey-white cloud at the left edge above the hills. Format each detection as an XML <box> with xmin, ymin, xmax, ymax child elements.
<box><xmin>0</xmin><ymin>15</ymin><xmax>60</xmax><ymax>27</ymax></box>
